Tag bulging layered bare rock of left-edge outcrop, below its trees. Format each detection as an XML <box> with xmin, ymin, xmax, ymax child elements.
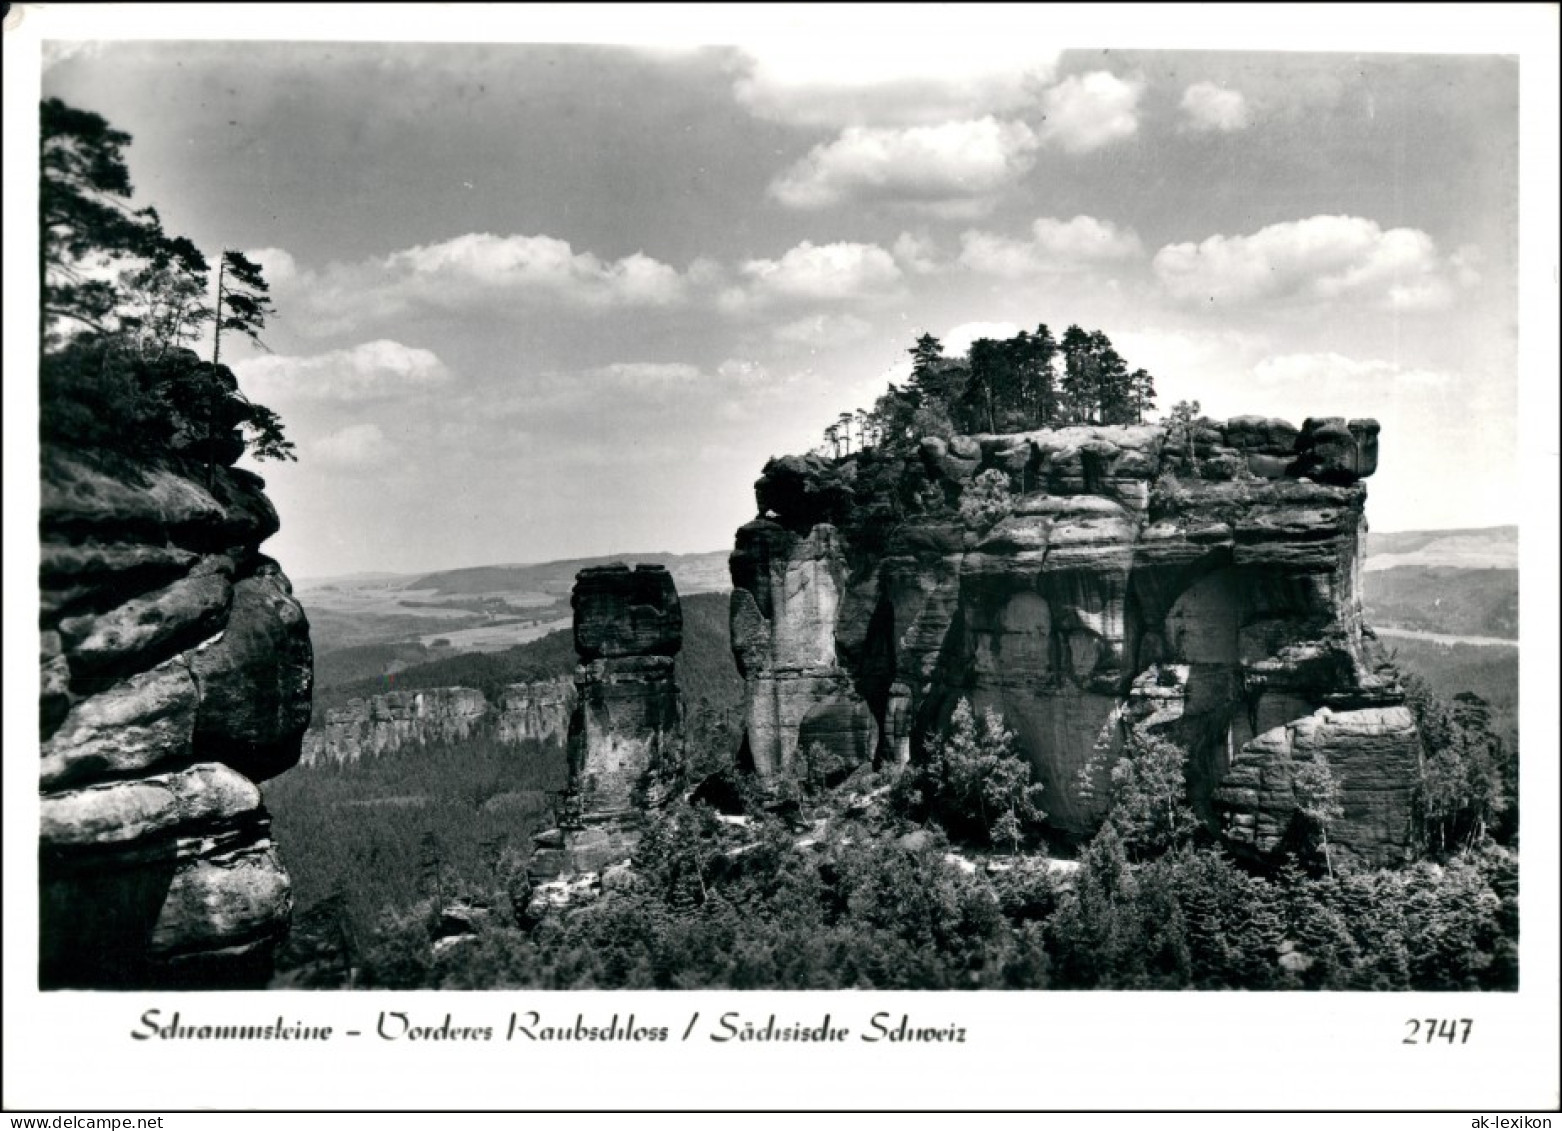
<box><xmin>39</xmin><ymin>448</ymin><xmax>312</xmax><ymax>989</ymax></box>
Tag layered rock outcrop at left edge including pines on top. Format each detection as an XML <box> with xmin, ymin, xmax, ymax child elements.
<box><xmin>39</xmin><ymin>100</ymin><xmax>312</xmax><ymax>989</ymax></box>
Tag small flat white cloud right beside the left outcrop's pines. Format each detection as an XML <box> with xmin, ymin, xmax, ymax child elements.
<box><xmin>234</xmin><ymin>339</ymin><xmax>451</xmax><ymax>401</ymax></box>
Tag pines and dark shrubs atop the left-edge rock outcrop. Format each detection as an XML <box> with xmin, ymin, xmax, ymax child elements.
<box><xmin>37</xmin><ymin>98</ymin><xmax>295</xmax><ymax>475</ymax></box>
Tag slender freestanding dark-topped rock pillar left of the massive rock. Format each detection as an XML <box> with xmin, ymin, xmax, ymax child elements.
<box><xmin>528</xmin><ymin>566</ymin><xmax>683</xmax><ymax>908</ymax></box>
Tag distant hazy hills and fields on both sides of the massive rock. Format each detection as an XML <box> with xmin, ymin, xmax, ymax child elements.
<box><xmin>297</xmin><ymin>526</ymin><xmax>1518</xmax><ymax>749</ymax></box>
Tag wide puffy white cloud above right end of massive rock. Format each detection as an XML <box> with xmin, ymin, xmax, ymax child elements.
<box><xmin>1154</xmin><ymin>216</ymin><xmax>1470</xmax><ymax>311</ymax></box>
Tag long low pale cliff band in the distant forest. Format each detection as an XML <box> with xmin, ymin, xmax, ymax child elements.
<box><xmin>300</xmin><ymin>678</ymin><xmax>575</xmax><ymax>765</ymax></box>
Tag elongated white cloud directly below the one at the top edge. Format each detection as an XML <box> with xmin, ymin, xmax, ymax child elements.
<box><xmin>770</xmin><ymin>117</ymin><xmax>1039</xmax><ymax>209</ymax></box>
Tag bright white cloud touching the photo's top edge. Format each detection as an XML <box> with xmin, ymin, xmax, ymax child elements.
<box><xmin>733</xmin><ymin>43</ymin><xmax>1057</xmax><ymax>128</ymax></box>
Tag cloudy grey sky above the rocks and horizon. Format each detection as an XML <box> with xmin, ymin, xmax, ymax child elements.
<box><xmin>30</xmin><ymin>11</ymin><xmax>1521</xmax><ymax>576</ymax></box>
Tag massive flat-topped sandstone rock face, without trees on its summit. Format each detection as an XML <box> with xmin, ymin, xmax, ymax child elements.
<box><xmin>731</xmin><ymin>417</ymin><xmax>1418</xmax><ymax>862</ymax></box>
